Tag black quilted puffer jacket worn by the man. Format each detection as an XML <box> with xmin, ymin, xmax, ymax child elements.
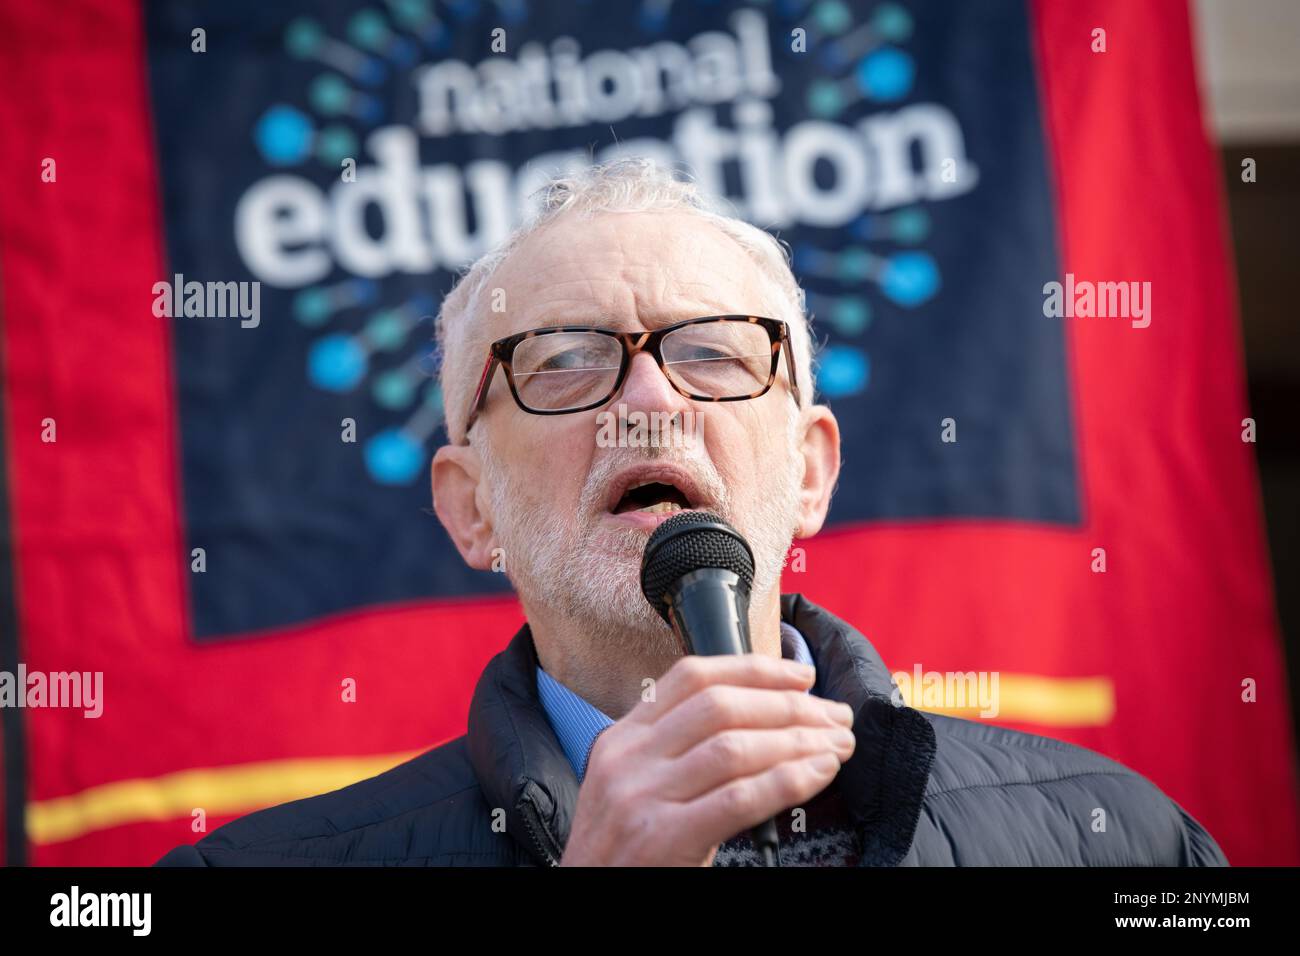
<box><xmin>157</xmin><ymin>594</ymin><xmax>1227</xmax><ymax>866</ymax></box>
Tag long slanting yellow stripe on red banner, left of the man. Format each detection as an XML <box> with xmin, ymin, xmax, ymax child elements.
<box><xmin>27</xmin><ymin>750</ymin><xmax>424</xmax><ymax>844</ymax></box>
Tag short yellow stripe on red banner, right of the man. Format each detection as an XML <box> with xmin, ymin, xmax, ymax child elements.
<box><xmin>893</xmin><ymin>671</ymin><xmax>1115</xmax><ymax>727</ymax></box>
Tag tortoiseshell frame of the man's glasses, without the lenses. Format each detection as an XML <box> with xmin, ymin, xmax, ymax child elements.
<box><xmin>460</xmin><ymin>315</ymin><xmax>800</xmax><ymax>445</ymax></box>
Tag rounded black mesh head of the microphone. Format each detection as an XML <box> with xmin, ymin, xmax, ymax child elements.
<box><xmin>641</xmin><ymin>511</ymin><xmax>754</xmax><ymax>623</ymax></box>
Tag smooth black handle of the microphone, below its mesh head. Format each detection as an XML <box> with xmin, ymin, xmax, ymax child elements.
<box><xmin>670</xmin><ymin>567</ymin><xmax>781</xmax><ymax>866</ymax></box>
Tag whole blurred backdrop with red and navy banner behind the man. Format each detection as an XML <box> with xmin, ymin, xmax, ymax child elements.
<box><xmin>0</xmin><ymin>0</ymin><xmax>1300</xmax><ymax>865</ymax></box>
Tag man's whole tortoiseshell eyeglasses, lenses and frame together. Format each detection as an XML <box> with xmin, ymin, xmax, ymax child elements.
<box><xmin>465</xmin><ymin>315</ymin><xmax>800</xmax><ymax>444</ymax></box>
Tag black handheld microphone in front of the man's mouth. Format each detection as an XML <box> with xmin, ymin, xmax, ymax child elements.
<box><xmin>641</xmin><ymin>511</ymin><xmax>780</xmax><ymax>866</ymax></box>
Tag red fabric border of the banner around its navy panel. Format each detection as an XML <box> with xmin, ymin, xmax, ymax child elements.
<box><xmin>0</xmin><ymin>0</ymin><xmax>1300</xmax><ymax>865</ymax></box>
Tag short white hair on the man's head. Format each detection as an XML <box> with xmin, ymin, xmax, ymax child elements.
<box><xmin>436</xmin><ymin>157</ymin><xmax>814</xmax><ymax>442</ymax></box>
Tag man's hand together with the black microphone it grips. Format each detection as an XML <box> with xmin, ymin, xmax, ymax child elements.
<box><xmin>560</xmin><ymin>511</ymin><xmax>854</xmax><ymax>866</ymax></box>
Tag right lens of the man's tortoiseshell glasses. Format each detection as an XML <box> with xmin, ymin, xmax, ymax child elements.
<box><xmin>663</xmin><ymin>319</ymin><xmax>772</xmax><ymax>398</ymax></box>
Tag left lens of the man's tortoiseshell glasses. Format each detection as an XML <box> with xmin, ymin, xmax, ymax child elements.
<box><xmin>511</xmin><ymin>332</ymin><xmax>623</xmax><ymax>411</ymax></box>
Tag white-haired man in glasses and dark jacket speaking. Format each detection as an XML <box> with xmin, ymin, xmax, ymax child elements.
<box><xmin>160</xmin><ymin>160</ymin><xmax>1227</xmax><ymax>866</ymax></box>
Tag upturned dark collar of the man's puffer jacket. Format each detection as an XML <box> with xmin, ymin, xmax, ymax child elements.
<box><xmin>467</xmin><ymin>594</ymin><xmax>935</xmax><ymax>866</ymax></box>
